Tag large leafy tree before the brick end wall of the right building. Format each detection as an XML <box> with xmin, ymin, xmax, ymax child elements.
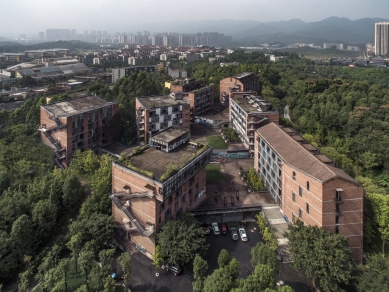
<box><xmin>286</xmin><ymin>220</ymin><xmax>355</xmax><ymax>291</ymax></box>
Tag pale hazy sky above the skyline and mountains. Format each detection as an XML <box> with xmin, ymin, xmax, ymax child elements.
<box><xmin>0</xmin><ymin>0</ymin><xmax>389</xmax><ymax>37</ymax></box>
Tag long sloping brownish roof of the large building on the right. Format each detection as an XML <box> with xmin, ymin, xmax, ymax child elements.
<box><xmin>256</xmin><ymin>123</ymin><xmax>358</xmax><ymax>184</ymax></box>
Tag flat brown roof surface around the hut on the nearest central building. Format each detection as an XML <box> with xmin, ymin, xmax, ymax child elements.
<box><xmin>127</xmin><ymin>144</ymin><xmax>206</xmax><ymax>180</ymax></box>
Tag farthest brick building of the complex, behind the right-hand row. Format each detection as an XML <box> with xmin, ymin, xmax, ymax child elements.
<box><xmin>220</xmin><ymin>72</ymin><xmax>259</xmax><ymax>103</ymax></box>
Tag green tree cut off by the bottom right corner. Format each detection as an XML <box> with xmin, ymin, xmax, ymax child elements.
<box><xmin>357</xmin><ymin>254</ymin><xmax>389</xmax><ymax>292</ymax></box>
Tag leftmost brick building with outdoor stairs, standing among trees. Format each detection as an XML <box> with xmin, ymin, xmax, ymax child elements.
<box><xmin>39</xmin><ymin>95</ymin><xmax>120</xmax><ymax>168</ymax></box>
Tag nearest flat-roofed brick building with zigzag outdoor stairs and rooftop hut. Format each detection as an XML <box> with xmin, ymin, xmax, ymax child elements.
<box><xmin>110</xmin><ymin>127</ymin><xmax>212</xmax><ymax>257</ymax></box>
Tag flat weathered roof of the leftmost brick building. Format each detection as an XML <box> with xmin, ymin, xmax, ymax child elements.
<box><xmin>43</xmin><ymin>95</ymin><xmax>116</xmax><ymax>117</ymax></box>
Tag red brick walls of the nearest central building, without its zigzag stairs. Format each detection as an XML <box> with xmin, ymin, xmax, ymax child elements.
<box><xmin>112</xmin><ymin>163</ymin><xmax>206</xmax><ymax>254</ymax></box>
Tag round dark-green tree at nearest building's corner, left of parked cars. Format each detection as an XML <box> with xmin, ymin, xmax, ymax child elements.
<box><xmin>157</xmin><ymin>214</ymin><xmax>208</xmax><ymax>264</ymax></box>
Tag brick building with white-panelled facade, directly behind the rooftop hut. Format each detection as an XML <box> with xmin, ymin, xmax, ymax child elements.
<box><xmin>135</xmin><ymin>94</ymin><xmax>190</xmax><ymax>143</ymax></box>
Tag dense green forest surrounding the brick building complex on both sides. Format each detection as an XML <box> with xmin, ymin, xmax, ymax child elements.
<box><xmin>0</xmin><ymin>51</ymin><xmax>389</xmax><ymax>291</ymax></box>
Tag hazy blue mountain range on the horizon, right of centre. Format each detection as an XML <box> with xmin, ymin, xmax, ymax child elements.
<box><xmin>146</xmin><ymin>16</ymin><xmax>389</xmax><ymax>45</ymax></box>
